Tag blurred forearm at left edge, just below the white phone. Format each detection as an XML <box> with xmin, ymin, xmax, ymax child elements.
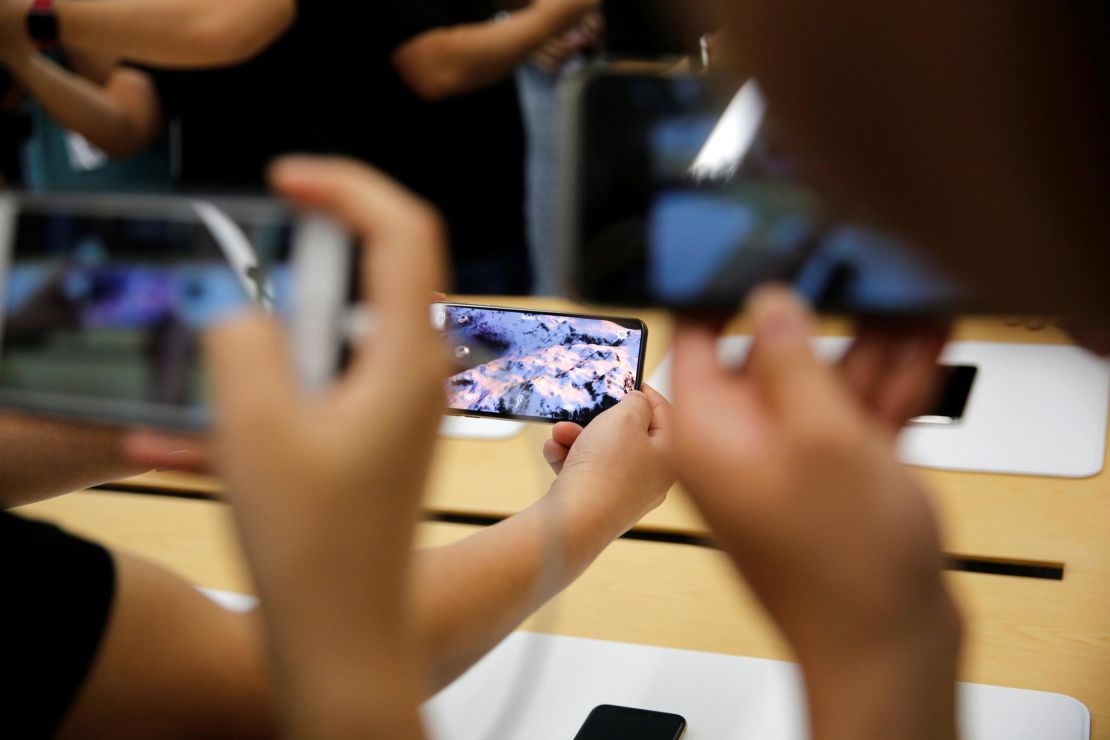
<box><xmin>0</xmin><ymin>414</ymin><xmax>142</xmax><ymax>507</ymax></box>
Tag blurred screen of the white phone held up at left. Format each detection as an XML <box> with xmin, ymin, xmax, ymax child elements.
<box><xmin>0</xmin><ymin>205</ymin><xmax>292</xmax><ymax>406</ymax></box>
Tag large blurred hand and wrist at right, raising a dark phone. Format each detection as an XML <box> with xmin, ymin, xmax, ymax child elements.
<box><xmin>674</xmin><ymin>288</ymin><xmax>959</xmax><ymax>738</ymax></box>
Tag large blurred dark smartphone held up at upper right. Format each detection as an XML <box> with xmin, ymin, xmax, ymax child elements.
<box><xmin>561</xmin><ymin>71</ymin><xmax>971</xmax><ymax>316</ymax></box>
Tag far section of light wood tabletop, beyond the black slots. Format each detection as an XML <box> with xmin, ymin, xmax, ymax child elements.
<box><xmin>118</xmin><ymin>296</ymin><xmax>1110</xmax><ymax>574</ymax></box>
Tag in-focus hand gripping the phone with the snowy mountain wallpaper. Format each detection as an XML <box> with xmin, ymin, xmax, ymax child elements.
<box><xmin>543</xmin><ymin>385</ymin><xmax>675</xmax><ymax>533</ymax></box>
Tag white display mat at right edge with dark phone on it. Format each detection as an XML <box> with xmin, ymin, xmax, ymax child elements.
<box><xmin>648</xmin><ymin>336</ymin><xmax>1110</xmax><ymax>478</ymax></box>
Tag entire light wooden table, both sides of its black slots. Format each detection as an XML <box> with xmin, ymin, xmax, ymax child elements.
<box><xmin>82</xmin><ymin>298</ymin><xmax>1110</xmax><ymax>740</ymax></box>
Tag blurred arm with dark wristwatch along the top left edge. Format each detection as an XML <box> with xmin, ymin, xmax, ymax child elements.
<box><xmin>0</xmin><ymin>0</ymin><xmax>296</xmax><ymax>67</ymax></box>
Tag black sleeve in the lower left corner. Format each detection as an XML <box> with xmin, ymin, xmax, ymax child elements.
<box><xmin>0</xmin><ymin>511</ymin><xmax>115</xmax><ymax>738</ymax></box>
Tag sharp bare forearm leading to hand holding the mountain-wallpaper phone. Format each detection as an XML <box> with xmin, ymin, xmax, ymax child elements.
<box><xmin>415</xmin><ymin>483</ymin><xmax>634</xmax><ymax>692</ymax></box>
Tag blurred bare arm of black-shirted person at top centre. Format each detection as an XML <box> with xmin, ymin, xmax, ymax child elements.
<box><xmin>393</xmin><ymin>0</ymin><xmax>597</xmax><ymax>100</ymax></box>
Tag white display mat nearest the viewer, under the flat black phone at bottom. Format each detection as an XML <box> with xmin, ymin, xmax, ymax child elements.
<box><xmin>424</xmin><ymin>632</ymin><xmax>1090</xmax><ymax>740</ymax></box>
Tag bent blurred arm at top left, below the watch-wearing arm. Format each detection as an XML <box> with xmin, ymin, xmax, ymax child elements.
<box><xmin>0</xmin><ymin>43</ymin><xmax>162</xmax><ymax>156</ymax></box>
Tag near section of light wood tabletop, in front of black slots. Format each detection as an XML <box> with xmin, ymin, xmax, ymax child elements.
<box><xmin>19</xmin><ymin>491</ymin><xmax>1110</xmax><ymax>740</ymax></box>
